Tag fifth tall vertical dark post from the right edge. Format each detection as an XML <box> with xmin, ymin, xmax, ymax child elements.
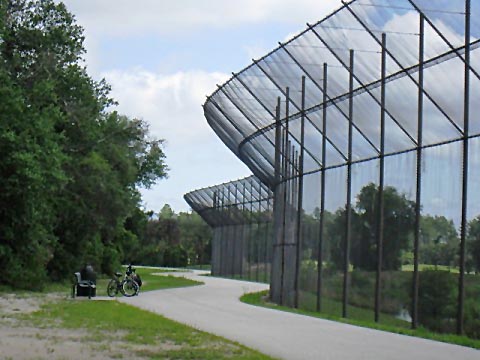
<box><xmin>317</xmin><ymin>63</ymin><xmax>328</xmax><ymax>311</ymax></box>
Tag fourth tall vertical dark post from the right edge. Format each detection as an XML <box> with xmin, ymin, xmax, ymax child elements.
<box><xmin>342</xmin><ymin>50</ymin><xmax>355</xmax><ymax>317</ymax></box>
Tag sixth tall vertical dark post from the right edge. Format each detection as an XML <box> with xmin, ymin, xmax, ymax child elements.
<box><xmin>294</xmin><ymin>76</ymin><xmax>305</xmax><ymax>308</ymax></box>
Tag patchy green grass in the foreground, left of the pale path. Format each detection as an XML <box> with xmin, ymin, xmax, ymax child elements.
<box><xmin>19</xmin><ymin>300</ymin><xmax>271</xmax><ymax>360</ymax></box>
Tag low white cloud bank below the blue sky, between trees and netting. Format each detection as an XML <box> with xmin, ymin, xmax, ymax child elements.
<box><xmin>102</xmin><ymin>69</ymin><xmax>250</xmax><ymax>211</ymax></box>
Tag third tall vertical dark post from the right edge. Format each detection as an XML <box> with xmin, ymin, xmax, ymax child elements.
<box><xmin>375</xmin><ymin>33</ymin><xmax>387</xmax><ymax>322</ymax></box>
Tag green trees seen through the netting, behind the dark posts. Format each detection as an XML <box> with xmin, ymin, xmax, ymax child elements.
<box><xmin>303</xmin><ymin>183</ymin><xmax>480</xmax><ymax>273</ymax></box>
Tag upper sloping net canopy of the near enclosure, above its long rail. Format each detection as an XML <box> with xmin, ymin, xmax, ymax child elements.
<box><xmin>204</xmin><ymin>0</ymin><xmax>480</xmax><ymax>188</ymax></box>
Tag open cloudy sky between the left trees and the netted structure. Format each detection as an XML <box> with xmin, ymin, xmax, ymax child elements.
<box><xmin>56</xmin><ymin>0</ymin><xmax>341</xmax><ymax>212</ymax></box>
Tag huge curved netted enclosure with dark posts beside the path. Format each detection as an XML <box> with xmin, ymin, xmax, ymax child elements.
<box><xmin>186</xmin><ymin>0</ymin><xmax>480</xmax><ymax>333</ymax></box>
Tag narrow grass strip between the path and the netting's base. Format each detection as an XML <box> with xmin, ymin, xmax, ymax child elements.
<box><xmin>240</xmin><ymin>291</ymin><xmax>480</xmax><ymax>349</ymax></box>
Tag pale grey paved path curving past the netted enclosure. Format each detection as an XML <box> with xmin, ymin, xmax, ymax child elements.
<box><xmin>120</xmin><ymin>272</ymin><xmax>480</xmax><ymax>360</ymax></box>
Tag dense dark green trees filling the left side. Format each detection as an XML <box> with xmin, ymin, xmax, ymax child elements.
<box><xmin>0</xmin><ymin>0</ymin><xmax>167</xmax><ymax>288</ymax></box>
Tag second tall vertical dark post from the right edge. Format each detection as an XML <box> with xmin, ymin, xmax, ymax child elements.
<box><xmin>412</xmin><ymin>14</ymin><xmax>425</xmax><ymax>329</ymax></box>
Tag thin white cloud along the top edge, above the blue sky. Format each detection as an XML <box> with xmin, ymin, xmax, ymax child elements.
<box><xmin>59</xmin><ymin>0</ymin><xmax>342</xmax><ymax>36</ymax></box>
